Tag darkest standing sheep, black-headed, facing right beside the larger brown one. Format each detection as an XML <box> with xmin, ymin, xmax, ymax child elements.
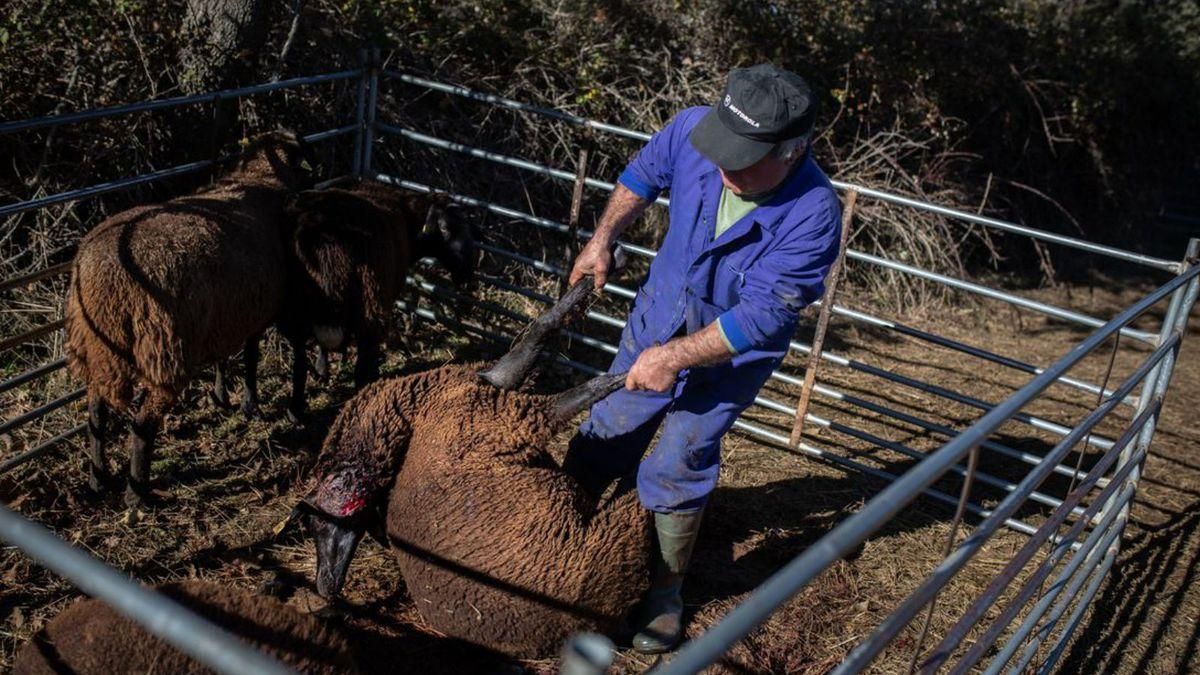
<box><xmin>280</xmin><ymin>181</ymin><xmax>474</xmax><ymax>416</ymax></box>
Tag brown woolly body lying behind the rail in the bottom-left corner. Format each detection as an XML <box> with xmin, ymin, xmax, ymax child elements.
<box><xmin>13</xmin><ymin>580</ymin><xmax>358</xmax><ymax>675</ymax></box>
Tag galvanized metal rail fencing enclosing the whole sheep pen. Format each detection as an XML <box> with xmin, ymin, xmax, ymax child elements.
<box><xmin>0</xmin><ymin>53</ymin><xmax>1200</xmax><ymax>673</ymax></box>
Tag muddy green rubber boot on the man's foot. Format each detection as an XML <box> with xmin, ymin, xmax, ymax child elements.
<box><xmin>634</xmin><ymin>509</ymin><xmax>704</xmax><ymax>653</ymax></box>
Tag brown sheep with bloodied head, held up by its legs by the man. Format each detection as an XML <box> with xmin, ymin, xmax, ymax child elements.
<box><xmin>295</xmin><ymin>280</ymin><xmax>650</xmax><ymax>658</ymax></box>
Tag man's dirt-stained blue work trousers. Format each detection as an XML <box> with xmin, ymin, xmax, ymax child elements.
<box><xmin>564</xmin><ymin>329</ymin><xmax>778</xmax><ymax>513</ymax></box>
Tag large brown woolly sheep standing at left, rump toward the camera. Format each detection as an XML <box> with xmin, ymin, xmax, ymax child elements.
<box><xmin>65</xmin><ymin>132</ymin><xmax>307</xmax><ymax>504</ymax></box>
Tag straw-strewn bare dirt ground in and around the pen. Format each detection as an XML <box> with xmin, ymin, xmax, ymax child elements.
<box><xmin>0</xmin><ymin>265</ymin><xmax>1200</xmax><ymax>673</ymax></box>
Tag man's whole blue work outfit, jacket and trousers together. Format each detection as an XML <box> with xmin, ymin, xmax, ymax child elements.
<box><xmin>566</xmin><ymin>107</ymin><xmax>841</xmax><ymax>513</ymax></box>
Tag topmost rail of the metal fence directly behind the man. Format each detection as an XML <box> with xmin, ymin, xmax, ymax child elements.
<box><xmin>384</xmin><ymin>71</ymin><xmax>1180</xmax><ymax>271</ymax></box>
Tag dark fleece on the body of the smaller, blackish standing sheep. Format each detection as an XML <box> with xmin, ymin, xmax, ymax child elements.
<box><xmin>281</xmin><ymin>181</ymin><xmax>431</xmax><ymax>340</ymax></box>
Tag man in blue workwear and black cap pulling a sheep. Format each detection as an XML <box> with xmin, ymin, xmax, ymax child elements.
<box><xmin>566</xmin><ymin>64</ymin><xmax>841</xmax><ymax>653</ymax></box>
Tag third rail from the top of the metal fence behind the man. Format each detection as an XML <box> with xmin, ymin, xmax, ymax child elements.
<box><xmin>374</xmin><ymin>174</ymin><xmax>1118</xmax><ymax>400</ymax></box>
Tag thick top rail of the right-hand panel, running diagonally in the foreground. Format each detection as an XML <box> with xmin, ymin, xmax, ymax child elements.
<box><xmin>662</xmin><ymin>261</ymin><xmax>1200</xmax><ymax>675</ymax></box>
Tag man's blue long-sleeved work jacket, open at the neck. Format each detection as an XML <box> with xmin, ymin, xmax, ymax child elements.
<box><xmin>619</xmin><ymin>107</ymin><xmax>841</xmax><ymax>384</ymax></box>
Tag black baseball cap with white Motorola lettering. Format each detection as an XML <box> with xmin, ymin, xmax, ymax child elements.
<box><xmin>689</xmin><ymin>64</ymin><xmax>817</xmax><ymax>171</ymax></box>
